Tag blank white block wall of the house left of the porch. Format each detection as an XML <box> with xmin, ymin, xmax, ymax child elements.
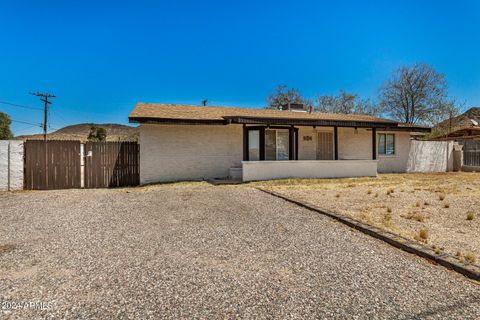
<box><xmin>140</xmin><ymin>124</ymin><xmax>243</xmax><ymax>184</ymax></box>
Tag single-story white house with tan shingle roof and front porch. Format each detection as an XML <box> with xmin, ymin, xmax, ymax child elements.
<box><xmin>129</xmin><ymin>103</ymin><xmax>430</xmax><ymax>184</ymax></box>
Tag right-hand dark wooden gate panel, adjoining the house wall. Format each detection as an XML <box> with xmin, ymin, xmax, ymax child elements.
<box><xmin>84</xmin><ymin>142</ymin><xmax>140</xmax><ymax>188</ymax></box>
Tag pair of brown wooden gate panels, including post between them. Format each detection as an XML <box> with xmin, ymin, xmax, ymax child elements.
<box><xmin>24</xmin><ymin>140</ymin><xmax>140</xmax><ymax>190</ymax></box>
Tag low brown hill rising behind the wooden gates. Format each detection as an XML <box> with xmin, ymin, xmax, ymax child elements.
<box><xmin>15</xmin><ymin>123</ymin><xmax>139</xmax><ymax>141</ymax></box>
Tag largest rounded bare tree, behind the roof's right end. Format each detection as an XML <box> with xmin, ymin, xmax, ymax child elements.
<box><xmin>380</xmin><ymin>64</ymin><xmax>456</xmax><ymax>124</ymax></box>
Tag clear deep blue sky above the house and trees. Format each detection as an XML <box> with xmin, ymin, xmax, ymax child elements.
<box><xmin>0</xmin><ymin>0</ymin><xmax>480</xmax><ymax>134</ymax></box>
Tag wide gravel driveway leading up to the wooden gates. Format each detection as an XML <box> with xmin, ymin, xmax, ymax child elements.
<box><xmin>0</xmin><ymin>183</ymin><xmax>480</xmax><ymax>319</ymax></box>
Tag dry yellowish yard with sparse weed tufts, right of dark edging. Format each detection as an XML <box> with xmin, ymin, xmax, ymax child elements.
<box><xmin>253</xmin><ymin>173</ymin><xmax>480</xmax><ymax>265</ymax></box>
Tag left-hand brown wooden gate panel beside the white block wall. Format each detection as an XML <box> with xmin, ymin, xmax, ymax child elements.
<box><xmin>24</xmin><ymin>140</ymin><xmax>80</xmax><ymax>190</ymax></box>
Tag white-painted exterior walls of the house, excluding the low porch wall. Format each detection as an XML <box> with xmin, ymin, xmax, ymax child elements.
<box><xmin>140</xmin><ymin>124</ymin><xmax>410</xmax><ymax>184</ymax></box>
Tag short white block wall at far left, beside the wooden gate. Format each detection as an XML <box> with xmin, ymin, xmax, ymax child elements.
<box><xmin>0</xmin><ymin>140</ymin><xmax>24</xmax><ymax>191</ymax></box>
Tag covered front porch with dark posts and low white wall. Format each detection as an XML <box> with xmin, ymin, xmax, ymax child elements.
<box><xmin>238</xmin><ymin>125</ymin><xmax>380</xmax><ymax>181</ymax></box>
